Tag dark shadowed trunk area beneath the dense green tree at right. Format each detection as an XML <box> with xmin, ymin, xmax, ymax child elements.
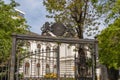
<box><xmin>107</xmin><ymin>67</ymin><xmax>119</xmax><ymax>80</ymax></box>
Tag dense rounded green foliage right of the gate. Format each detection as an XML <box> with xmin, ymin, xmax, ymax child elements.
<box><xmin>98</xmin><ymin>19</ymin><xmax>120</xmax><ymax>69</ymax></box>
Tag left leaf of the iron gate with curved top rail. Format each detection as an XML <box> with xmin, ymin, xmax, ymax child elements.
<box><xmin>16</xmin><ymin>44</ymin><xmax>57</xmax><ymax>80</ymax></box>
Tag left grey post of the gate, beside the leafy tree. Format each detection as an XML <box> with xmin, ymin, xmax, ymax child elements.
<box><xmin>10</xmin><ymin>35</ymin><xmax>16</xmax><ymax>80</ymax></box>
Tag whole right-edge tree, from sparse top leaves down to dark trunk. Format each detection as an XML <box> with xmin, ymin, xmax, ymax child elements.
<box><xmin>98</xmin><ymin>0</ymin><xmax>120</xmax><ymax>80</ymax></box>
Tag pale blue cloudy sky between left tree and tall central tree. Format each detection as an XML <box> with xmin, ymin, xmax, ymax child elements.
<box><xmin>4</xmin><ymin>0</ymin><xmax>53</xmax><ymax>34</ymax></box>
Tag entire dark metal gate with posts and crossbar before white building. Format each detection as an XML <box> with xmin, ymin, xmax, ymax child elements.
<box><xmin>10</xmin><ymin>34</ymin><xmax>97</xmax><ymax>80</ymax></box>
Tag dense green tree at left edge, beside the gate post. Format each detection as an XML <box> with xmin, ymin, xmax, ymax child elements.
<box><xmin>0</xmin><ymin>0</ymin><xmax>29</xmax><ymax>70</ymax></box>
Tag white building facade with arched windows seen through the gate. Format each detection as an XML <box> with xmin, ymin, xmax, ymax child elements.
<box><xmin>19</xmin><ymin>41</ymin><xmax>76</xmax><ymax>77</ymax></box>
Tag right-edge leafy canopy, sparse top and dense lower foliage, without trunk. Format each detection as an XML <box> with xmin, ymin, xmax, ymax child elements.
<box><xmin>98</xmin><ymin>0</ymin><xmax>120</xmax><ymax>68</ymax></box>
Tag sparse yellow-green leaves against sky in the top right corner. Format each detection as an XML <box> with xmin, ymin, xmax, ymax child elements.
<box><xmin>97</xmin><ymin>0</ymin><xmax>120</xmax><ymax>24</ymax></box>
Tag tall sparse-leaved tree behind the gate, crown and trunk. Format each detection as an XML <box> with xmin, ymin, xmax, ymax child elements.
<box><xmin>44</xmin><ymin>0</ymin><xmax>100</xmax><ymax>77</ymax></box>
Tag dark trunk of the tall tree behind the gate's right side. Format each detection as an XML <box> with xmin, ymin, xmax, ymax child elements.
<box><xmin>77</xmin><ymin>25</ymin><xmax>87</xmax><ymax>80</ymax></box>
